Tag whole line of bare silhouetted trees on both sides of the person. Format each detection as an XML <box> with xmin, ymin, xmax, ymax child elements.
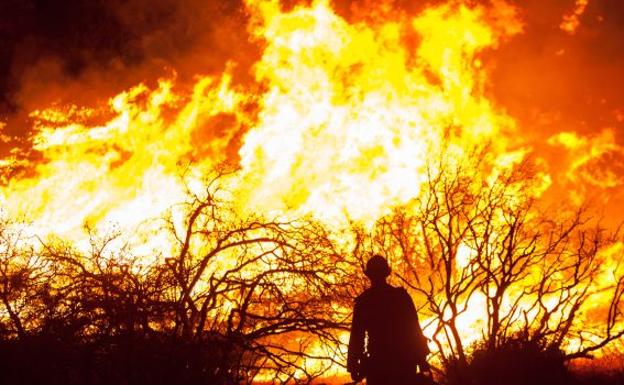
<box><xmin>0</xmin><ymin>153</ymin><xmax>624</xmax><ymax>384</ymax></box>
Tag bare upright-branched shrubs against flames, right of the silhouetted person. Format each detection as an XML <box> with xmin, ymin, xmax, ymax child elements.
<box><xmin>360</xmin><ymin>157</ymin><xmax>624</xmax><ymax>365</ymax></box>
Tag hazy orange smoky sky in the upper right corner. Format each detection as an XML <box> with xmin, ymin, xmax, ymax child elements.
<box><xmin>490</xmin><ymin>0</ymin><xmax>624</xmax><ymax>139</ymax></box>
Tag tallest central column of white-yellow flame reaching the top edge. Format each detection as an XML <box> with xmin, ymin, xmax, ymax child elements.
<box><xmin>240</xmin><ymin>1</ymin><xmax>514</xmax><ymax>220</ymax></box>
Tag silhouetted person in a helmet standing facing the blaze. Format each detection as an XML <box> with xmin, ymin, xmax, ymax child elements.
<box><xmin>347</xmin><ymin>255</ymin><xmax>429</xmax><ymax>385</ymax></box>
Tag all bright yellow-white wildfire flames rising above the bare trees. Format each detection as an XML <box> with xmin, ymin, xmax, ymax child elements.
<box><xmin>0</xmin><ymin>0</ymin><xmax>624</xmax><ymax>380</ymax></box>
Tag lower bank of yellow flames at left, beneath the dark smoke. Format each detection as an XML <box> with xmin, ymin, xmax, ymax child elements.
<box><xmin>2</xmin><ymin>74</ymin><xmax>246</xmax><ymax>240</ymax></box>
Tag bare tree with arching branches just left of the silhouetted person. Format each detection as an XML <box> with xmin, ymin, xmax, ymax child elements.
<box><xmin>158</xmin><ymin>179</ymin><xmax>348</xmax><ymax>381</ymax></box>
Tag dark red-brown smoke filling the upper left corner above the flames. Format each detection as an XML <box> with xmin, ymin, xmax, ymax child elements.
<box><xmin>0</xmin><ymin>0</ymin><xmax>257</xmax><ymax>151</ymax></box>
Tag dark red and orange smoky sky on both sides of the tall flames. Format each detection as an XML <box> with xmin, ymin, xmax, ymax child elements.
<box><xmin>0</xmin><ymin>0</ymin><xmax>624</xmax><ymax>139</ymax></box>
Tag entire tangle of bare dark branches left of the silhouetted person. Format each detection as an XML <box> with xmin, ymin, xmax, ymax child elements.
<box><xmin>0</xmin><ymin>178</ymin><xmax>352</xmax><ymax>383</ymax></box>
